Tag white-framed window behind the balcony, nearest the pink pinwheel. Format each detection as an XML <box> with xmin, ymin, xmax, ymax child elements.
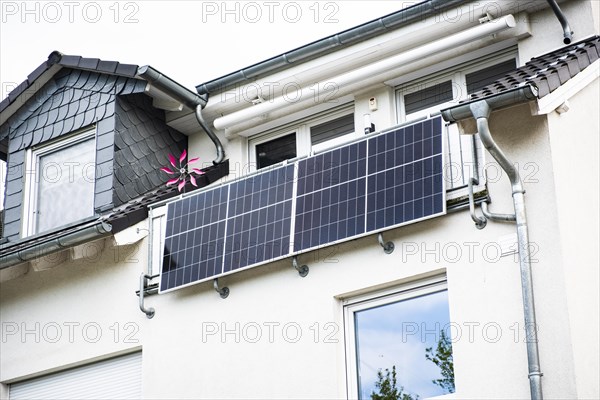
<box><xmin>248</xmin><ymin>105</ymin><xmax>358</xmax><ymax>169</ymax></box>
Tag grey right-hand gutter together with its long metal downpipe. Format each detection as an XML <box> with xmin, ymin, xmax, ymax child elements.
<box><xmin>442</xmin><ymin>86</ymin><xmax>543</xmax><ymax>400</ymax></box>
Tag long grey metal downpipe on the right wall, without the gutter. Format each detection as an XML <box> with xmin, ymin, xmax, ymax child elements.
<box><xmin>470</xmin><ymin>100</ymin><xmax>543</xmax><ymax>400</ymax></box>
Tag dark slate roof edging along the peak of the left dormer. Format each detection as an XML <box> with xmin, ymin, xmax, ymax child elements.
<box><xmin>0</xmin><ymin>51</ymin><xmax>139</xmax><ymax>112</ymax></box>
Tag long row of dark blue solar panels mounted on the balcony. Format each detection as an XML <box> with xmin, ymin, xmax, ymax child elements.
<box><xmin>159</xmin><ymin>117</ymin><xmax>446</xmax><ymax>293</ymax></box>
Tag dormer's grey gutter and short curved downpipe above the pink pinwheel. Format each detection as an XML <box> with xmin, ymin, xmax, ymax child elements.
<box><xmin>138</xmin><ymin>65</ymin><xmax>225</xmax><ymax>165</ymax></box>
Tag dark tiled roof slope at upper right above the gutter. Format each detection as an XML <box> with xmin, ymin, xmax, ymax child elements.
<box><xmin>465</xmin><ymin>36</ymin><xmax>600</xmax><ymax>102</ymax></box>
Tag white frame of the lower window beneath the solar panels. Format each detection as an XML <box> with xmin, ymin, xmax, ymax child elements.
<box><xmin>342</xmin><ymin>274</ymin><xmax>450</xmax><ymax>399</ymax></box>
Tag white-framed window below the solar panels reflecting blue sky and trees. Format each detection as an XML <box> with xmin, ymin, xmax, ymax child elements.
<box><xmin>344</xmin><ymin>277</ymin><xmax>454</xmax><ymax>400</ymax></box>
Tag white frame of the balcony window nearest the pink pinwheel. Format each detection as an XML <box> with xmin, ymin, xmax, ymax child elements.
<box><xmin>248</xmin><ymin>103</ymin><xmax>356</xmax><ymax>172</ymax></box>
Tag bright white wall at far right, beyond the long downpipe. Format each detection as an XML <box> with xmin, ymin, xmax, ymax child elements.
<box><xmin>548</xmin><ymin>78</ymin><xmax>600</xmax><ymax>398</ymax></box>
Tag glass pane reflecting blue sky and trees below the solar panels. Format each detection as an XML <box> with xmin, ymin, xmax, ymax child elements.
<box><xmin>355</xmin><ymin>290</ymin><xmax>454</xmax><ymax>400</ymax></box>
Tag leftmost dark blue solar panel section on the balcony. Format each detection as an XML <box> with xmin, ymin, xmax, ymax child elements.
<box><xmin>160</xmin><ymin>186</ymin><xmax>229</xmax><ymax>291</ymax></box>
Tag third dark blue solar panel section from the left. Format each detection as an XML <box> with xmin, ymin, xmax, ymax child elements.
<box><xmin>294</xmin><ymin>141</ymin><xmax>367</xmax><ymax>251</ymax></box>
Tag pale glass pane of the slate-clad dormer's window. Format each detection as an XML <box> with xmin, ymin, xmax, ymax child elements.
<box><xmin>36</xmin><ymin>138</ymin><xmax>96</xmax><ymax>233</ymax></box>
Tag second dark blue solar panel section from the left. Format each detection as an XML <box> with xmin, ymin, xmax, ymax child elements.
<box><xmin>224</xmin><ymin>165</ymin><xmax>294</xmax><ymax>272</ymax></box>
